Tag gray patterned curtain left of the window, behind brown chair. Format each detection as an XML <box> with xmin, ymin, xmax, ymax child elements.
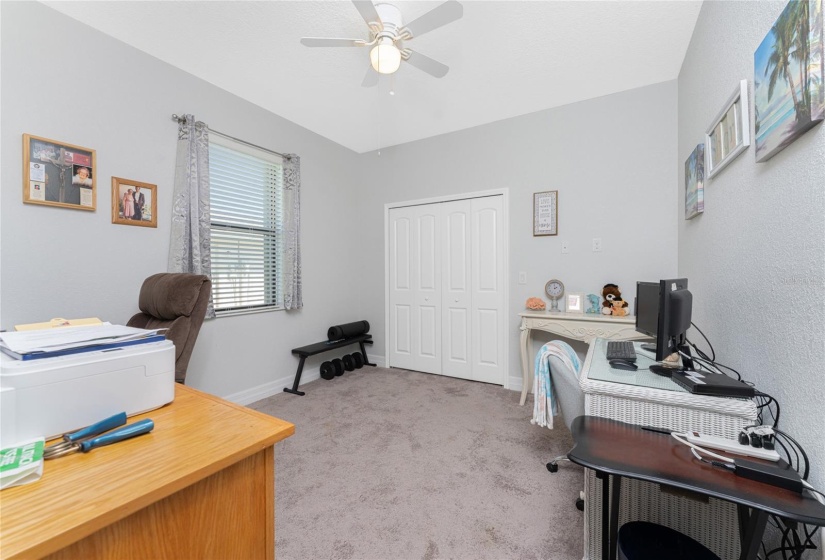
<box><xmin>168</xmin><ymin>115</ymin><xmax>215</xmax><ymax>319</ymax></box>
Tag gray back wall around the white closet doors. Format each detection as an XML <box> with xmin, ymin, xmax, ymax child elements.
<box><xmin>360</xmin><ymin>81</ymin><xmax>677</xmax><ymax>387</ymax></box>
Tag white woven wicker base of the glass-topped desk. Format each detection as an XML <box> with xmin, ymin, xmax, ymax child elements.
<box><xmin>580</xmin><ymin>344</ymin><xmax>756</xmax><ymax>560</ymax></box>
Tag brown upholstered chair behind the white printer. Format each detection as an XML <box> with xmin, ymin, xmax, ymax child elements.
<box><xmin>126</xmin><ymin>272</ymin><xmax>212</xmax><ymax>383</ymax></box>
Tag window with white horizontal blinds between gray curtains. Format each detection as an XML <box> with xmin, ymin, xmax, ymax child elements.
<box><xmin>209</xmin><ymin>132</ymin><xmax>283</xmax><ymax>316</ymax></box>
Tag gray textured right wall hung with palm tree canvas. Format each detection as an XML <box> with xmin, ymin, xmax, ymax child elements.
<box><xmin>674</xmin><ymin>2</ymin><xmax>825</xmax><ymax>508</ymax></box>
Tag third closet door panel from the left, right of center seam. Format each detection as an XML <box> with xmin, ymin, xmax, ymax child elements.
<box><xmin>442</xmin><ymin>200</ymin><xmax>472</xmax><ymax>379</ymax></box>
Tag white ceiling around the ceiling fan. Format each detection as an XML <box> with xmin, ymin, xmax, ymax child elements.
<box><xmin>47</xmin><ymin>0</ymin><xmax>701</xmax><ymax>152</ymax></box>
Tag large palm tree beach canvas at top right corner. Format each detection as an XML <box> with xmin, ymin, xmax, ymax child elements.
<box><xmin>753</xmin><ymin>0</ymin><xmax>825</xmax><ymax>162</ymax></box>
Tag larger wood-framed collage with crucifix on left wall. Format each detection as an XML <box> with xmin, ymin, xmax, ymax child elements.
<box><xmin>23</xmin><ymin>134</ymin><xmax>97</xmax><ymax>211</ymax></box>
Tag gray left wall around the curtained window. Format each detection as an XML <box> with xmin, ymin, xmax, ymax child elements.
<box><xmin>0</xmin><ymin>2</ymin><xmax>361</xmax><ymax>396</ymax></box>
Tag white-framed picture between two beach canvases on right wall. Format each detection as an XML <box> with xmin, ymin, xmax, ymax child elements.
<box><xmin>705</xmin><ymin>80</ymin><xmax>751</xmax><ymax>179</ymax></box>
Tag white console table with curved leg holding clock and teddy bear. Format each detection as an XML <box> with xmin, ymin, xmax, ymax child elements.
<box><xmin>519</xmin><ymin>311</ymin><xmax>649</xmax><ymax>405</ymax></box>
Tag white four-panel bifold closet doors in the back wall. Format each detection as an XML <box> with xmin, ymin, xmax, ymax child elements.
<box><xmin>388</xmin><ymin>196</ymin><xmax>506</xmax><ymax>384</ymax></box>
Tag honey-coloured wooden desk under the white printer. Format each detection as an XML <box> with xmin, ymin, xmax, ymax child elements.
<box><xmin>0</xmin><ymin>385</ymin><xmax>295</xmax><ymax>559</ymax></box>
